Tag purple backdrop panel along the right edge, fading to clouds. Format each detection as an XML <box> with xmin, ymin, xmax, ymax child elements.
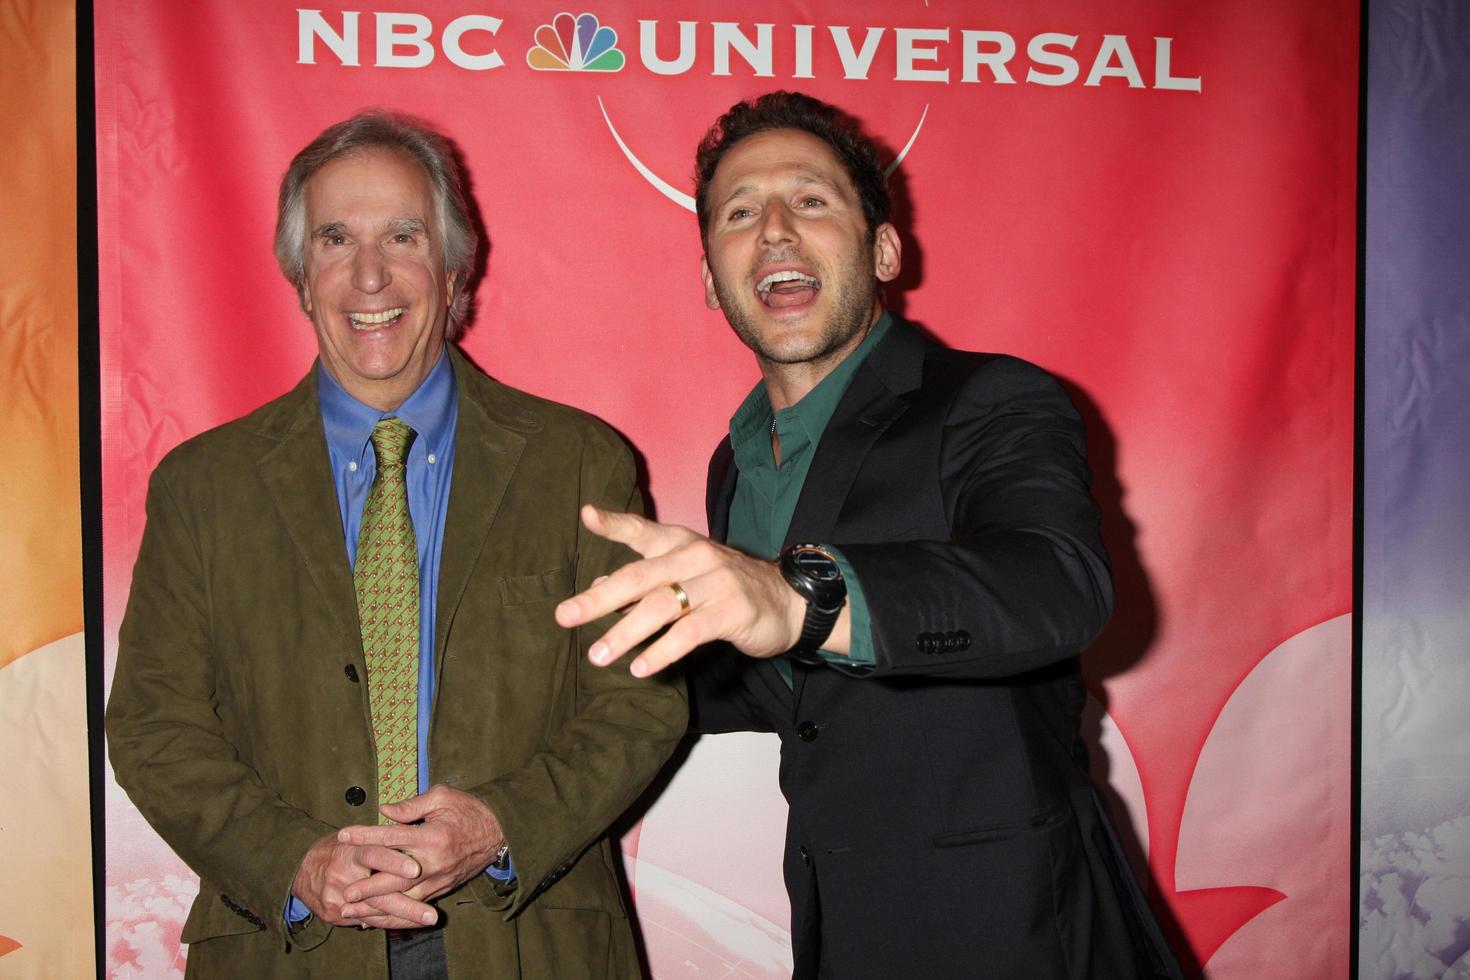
<box><xmin>1360</xmin><ymin>0</ymin><xmax>1470</xmax><ymax>977</ymax></box>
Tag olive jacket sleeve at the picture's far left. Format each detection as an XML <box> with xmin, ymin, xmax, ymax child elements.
<box><xmin>106</xmin><ymin>461</ymin><xmax>335</xmax><ymax>945</ymax></box>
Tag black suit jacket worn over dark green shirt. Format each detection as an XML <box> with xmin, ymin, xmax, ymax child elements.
<box><xmin>689</xmin><ymin>317</ymin><xmax>1177</xmax><ymax>980</ymax></box>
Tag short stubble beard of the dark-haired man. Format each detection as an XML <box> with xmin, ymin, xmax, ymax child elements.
<box><xmin>714</xmin><ymin>245</ymin><xmax>878</xmax><ymax>364</ymax></box>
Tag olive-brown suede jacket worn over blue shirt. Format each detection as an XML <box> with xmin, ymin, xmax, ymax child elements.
<box><xmin>107</xmin><ymin>348</ymin><xmax>686</xmax><ymax>977</ymax></box>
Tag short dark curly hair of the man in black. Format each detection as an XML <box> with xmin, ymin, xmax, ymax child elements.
<box><xmin>694</xmin><ymin>91</ymin><xmax>892</xmax><ymax>241</ymax></box>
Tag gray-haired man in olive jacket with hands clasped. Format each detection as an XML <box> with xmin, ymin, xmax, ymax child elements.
<box><xmin>107</xmin><ymin>113</ymin><xmax>686</xmax><ymax>980</ymax></box>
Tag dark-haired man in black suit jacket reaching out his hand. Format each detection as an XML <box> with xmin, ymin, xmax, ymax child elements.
<box><xmin>557</xmin><ymin>93</ymin><xmax>1177</xmax><ymax>980</ymax></box>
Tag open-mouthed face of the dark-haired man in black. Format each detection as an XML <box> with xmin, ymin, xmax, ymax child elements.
<box><xmin>703</xmin><ymin>129</ymin><xmax>900</xmax><ymax>378</ymax></box>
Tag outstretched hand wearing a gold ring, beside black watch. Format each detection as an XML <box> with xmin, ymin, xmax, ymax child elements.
<box><xmin>556</xmin><ymin>504</ymin><xmax>817</xmax><ymax>677</ymax></box>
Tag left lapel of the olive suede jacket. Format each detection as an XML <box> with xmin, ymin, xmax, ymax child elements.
<box><xmin>259</xmin><ymin>367</ymin><xmax>362</xmax><ymax>660</ymax></box>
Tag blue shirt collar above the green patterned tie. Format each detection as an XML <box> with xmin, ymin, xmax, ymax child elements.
<box><xmin>316</xmin><ymin>347</ymin><xmax>459</xmax><ymax>460</ymax></box>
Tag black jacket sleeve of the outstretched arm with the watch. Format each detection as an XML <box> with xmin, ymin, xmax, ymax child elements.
<box><xmin>832</xmin><ymin>357</ymin><xmax>1113</xmax><ymax>680</ymax></box>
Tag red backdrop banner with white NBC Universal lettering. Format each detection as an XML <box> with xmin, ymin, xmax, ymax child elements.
<box><xmin>96</xmin><ymin>0</ymin><xmax>1358</xmax><ymax>979</ymax></box>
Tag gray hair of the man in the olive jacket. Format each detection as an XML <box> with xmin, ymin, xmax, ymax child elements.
<box><xmin>275</xmin><ymin>109</ymin><xmax>479</xmax><ymax>339</ymax></box>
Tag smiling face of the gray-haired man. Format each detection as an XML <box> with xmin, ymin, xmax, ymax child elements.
<box><xmin>303</xmin><ymin>147</ymin><xmax>454</xmax><ymax>411</ymax></box>
